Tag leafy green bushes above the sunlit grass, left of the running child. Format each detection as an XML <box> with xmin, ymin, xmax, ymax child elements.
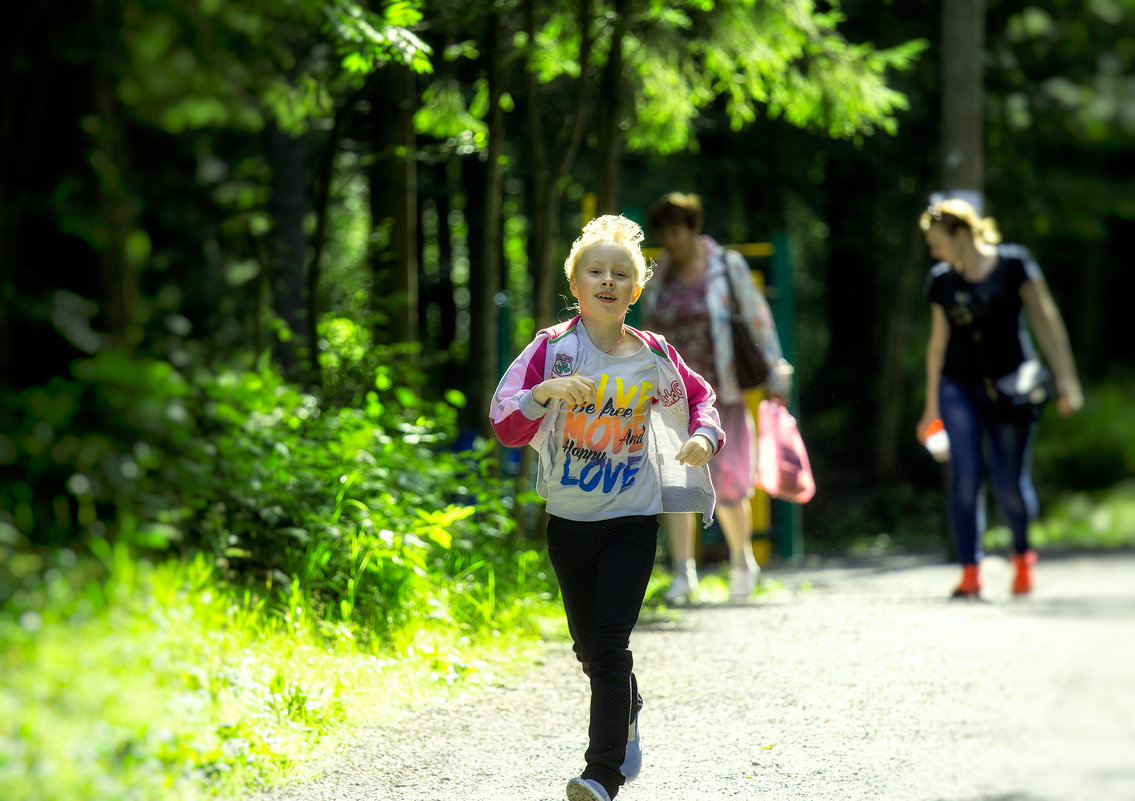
<box><xmin>0</xmin><ymin>326</ymin><xmax>554</xmax><ymax>638</ymax></box>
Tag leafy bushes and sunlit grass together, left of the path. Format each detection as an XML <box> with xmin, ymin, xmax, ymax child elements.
<box><xmin>0</xmin><ymin>321</ymin><xmax>556</xmax><ymax>801</ymax></box>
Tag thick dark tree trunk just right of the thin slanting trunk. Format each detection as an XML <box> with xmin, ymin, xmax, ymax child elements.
<box><xmin>370</xmin><ymin>64</ymin><xmax>418</xmax><ymax>343</ymax></box>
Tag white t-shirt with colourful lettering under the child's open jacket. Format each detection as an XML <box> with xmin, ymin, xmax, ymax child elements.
<box><xmin>547</xmin><ymin>324</ymin><xmax>662</xmax><ymax>521</ymax></box>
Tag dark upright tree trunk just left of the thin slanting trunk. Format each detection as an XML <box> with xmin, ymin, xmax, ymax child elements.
<box><xmin>268</xmin><ymin>125</ymin><xmax>312</xmax><ymax>386</ymax></box>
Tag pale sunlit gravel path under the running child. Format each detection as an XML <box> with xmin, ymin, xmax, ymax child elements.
<box><xmin>250</xmin><ymin>554</ymin><xmax>1135</xmax><ymax>801</ymax></box>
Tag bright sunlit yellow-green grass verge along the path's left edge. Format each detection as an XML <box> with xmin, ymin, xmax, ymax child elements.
<box><xmin>0</xmin><ymin>549</ymin><xmax>563</xmax><ymax>801</ymax></box>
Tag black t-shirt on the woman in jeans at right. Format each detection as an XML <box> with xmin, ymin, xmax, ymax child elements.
<box><xmin>927</xmin><ymin>244</ymin><xmax>1041</xmax><ymax>383</ymax></box>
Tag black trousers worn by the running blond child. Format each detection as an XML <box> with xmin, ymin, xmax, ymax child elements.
<box><xmin>548</xmin><ymin>515</ymin><xmax>658</xmax><ymax>798</ymax></box>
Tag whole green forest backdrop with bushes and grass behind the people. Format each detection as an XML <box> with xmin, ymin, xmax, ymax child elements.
<box><xmin>0</xmin><ymin>0</ymin><xmax>1135</xmax><ymax>798</ymax></box>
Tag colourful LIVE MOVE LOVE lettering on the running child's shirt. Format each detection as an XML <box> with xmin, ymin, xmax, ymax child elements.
<box><xmin>560</xmin><ymin>373</ymin><xmax>654</xmax><ymax>495</ymax></box>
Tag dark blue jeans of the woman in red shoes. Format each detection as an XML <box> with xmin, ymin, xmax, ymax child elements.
<box><xmin>938</xmin><ymin>377</ymin><xmax>1040</xmax><ymax>565</ymax></box>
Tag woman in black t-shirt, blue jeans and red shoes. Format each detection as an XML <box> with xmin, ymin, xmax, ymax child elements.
<box><xmin>917</xmin><ymin>200</ymin><xmax>1084</xmax><ymax>597</ymax></box>
